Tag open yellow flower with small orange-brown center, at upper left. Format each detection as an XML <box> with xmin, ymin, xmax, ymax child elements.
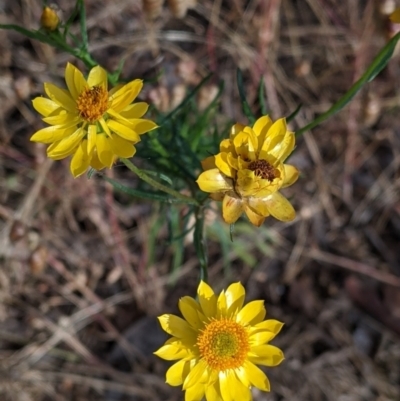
<box><xmin>31</xmin><ymin>63</ymin><xmax>157</xmax><ymax>177</ymax></box>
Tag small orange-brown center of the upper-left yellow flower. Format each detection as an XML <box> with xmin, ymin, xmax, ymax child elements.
<box><xmin>76</xmin><ymin>86</ymin><xmax>108</xmax><ymax>123</ymax></box>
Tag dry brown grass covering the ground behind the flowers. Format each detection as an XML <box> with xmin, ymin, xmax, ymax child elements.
<box><xmin>0</xmin><ymin>0</ymin><xmax>400</xmax><ymax>401</ymax></box>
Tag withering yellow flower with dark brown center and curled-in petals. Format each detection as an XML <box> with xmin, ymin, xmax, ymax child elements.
<box><xmin>197</xmin><ymin>116</ymin><xmax>299</xmax><ymax>226</ymax></box>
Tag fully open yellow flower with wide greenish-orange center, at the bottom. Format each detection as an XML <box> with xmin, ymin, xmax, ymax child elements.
<box><xmin>155</xmin><ymin>281</ymin><xmax>284</xmax><ymax>401</ymax></box>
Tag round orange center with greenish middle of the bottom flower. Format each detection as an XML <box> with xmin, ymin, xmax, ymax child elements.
<box><xmin>197</xmin><ymin>319</ymin><xmax>250</xmax><ymax>371</ymax></box>
